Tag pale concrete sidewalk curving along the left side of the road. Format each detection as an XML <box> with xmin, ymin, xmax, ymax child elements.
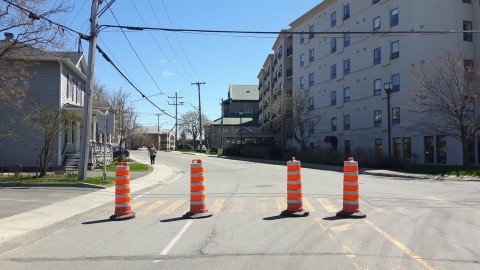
<box><xmin>0</xmin><ymin>160</ymin><xmax>175</xmax><ymax>243</ymax></box>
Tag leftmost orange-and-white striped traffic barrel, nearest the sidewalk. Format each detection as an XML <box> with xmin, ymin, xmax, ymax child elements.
<box><xmin>110</xmin><ymin>162</ymin><xmax>135</xmax><ymax>220</ymax></box>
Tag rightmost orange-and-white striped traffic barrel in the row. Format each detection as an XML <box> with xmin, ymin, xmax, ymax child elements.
<box><xmin>337</xmin><ymin>157</ymin><xmax>367</xmax><ymax>218</ymax></box>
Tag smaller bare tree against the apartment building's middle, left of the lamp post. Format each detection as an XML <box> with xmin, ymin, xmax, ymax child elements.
<box><xmin>289</xmin><ymin>90</ymin><xmax>321</xmax><ymax>150</ymax></box>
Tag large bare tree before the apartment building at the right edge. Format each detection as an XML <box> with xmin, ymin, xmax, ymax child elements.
<box><xmin>409</xmin><ymin>52</ymin><xmax>480</xmax><ymax>165</ymax></box>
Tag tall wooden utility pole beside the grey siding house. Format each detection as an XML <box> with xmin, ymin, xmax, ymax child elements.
<box><xmin>78</xmin><ymin>0</ymin><xmax>103</xmax><ymax>180</ymax></box>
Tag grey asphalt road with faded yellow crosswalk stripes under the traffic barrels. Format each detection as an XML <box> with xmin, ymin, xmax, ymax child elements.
<box><xmin>0</xmin><ymin>152</ymin><xmax>480</xmax><ymax>270</ymax></box>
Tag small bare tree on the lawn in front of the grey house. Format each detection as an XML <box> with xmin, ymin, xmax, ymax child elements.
<box><xmin>0</xmin><ymin>101</ymin><xmax>78</xmax><ymax>177</ymax></box>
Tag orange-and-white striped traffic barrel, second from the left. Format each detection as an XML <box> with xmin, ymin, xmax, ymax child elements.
<box><xmin>183</xmin><ymin>159</ymin><xmax>213</xmax><ymax>218</ymax></box>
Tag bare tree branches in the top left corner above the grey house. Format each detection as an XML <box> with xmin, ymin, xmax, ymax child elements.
<box><xmin>0</xmin><ymin>0</ymin><xmax>71</xmax><ymax>107</ymax></box>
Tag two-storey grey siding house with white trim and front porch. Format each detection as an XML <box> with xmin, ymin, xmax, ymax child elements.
<box><xmin>0</xmin><ymin>40</ymin><xmax>112</xmax><ymax>170</ymax></box>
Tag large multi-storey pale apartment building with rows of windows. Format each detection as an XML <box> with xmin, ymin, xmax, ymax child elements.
<box><xmin>258</xmin><ymin>0</ymin><xmax>480</xmax><ymax>164</ymax></box>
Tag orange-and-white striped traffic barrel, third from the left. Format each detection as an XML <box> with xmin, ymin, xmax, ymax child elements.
<box><xmin>281</xmin><ymin>157</ymin><xmax>309</xmax><ymax>217</ymax></box>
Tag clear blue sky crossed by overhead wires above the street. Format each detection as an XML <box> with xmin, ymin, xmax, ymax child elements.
<box><xmin>62</xmin><ymin>0</ymin><xmax>321</xmax><ymax>129</ymax></box>
